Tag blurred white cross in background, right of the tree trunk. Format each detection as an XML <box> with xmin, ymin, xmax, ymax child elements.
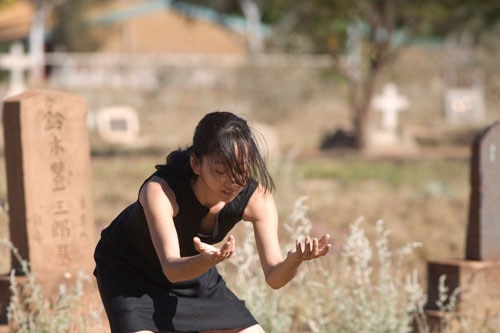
<box><xmin>372</xmin><ymin>83</ymin><xmax>408</xmax><ymax>132</ymax></box>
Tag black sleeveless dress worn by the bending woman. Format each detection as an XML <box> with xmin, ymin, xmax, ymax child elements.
<box><xmin>94</xmin><ymin>166</ymin><xmax>257</xmax><ymax>333</ymax></box>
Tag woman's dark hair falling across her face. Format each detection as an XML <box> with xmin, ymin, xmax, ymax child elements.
<box><xmin>161</xmin><ymin>111</ymin><xmax>275</xmax><ymax>191</ymax></box>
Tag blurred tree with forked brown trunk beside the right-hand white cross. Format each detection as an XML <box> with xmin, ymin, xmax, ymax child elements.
<box><xmin>281</xmin><ymin>0</ymin><xmax>500</xmax><ymax>149</ymax></box>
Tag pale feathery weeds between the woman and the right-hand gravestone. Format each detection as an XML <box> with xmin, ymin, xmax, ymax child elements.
<box><xmin>223</xmin><ymin>197</ymin><xmax>462</xmax><ymax>333</ymax></box>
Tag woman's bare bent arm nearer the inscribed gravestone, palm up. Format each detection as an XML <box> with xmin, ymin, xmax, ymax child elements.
<box><xmin>139</xmin><ymin>177</ymin><xmax>234</xmax><ymax>282</ymax></box>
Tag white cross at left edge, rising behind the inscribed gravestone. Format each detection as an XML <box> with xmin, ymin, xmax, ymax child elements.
<box><xmin>0</xmin><ymin>43</ymin><xmax>31</xmax><ymax>98</ymax></box>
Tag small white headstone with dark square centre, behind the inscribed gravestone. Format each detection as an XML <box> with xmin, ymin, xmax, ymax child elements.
<box><xmin>96</xmin><ymin>105</ymin><xmax>139</xmax><ymax>143</ymax></box>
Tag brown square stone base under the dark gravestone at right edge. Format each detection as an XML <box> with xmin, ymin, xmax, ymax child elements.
<box><xmin>426</xmin><ymin>259</ymin><xmax>500</xmax><ymax>316</ymax></box>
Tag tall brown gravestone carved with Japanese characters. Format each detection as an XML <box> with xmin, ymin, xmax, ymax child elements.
<box><xmin>3</xmin><ymin>91</ymin><xmax>93</xmax><ymax>287</ymax></box>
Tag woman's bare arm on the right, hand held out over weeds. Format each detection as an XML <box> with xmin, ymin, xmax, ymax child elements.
<box><xmin>243</xmin><ymin>187</ymin><xmax>331</xmax><ymax>289</ymax></box>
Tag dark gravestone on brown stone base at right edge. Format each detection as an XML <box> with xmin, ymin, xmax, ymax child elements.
<box><xmin>426</xmin><ymin>121</ymin><xmax>500</xmax><ymax>322</ymax></box>
